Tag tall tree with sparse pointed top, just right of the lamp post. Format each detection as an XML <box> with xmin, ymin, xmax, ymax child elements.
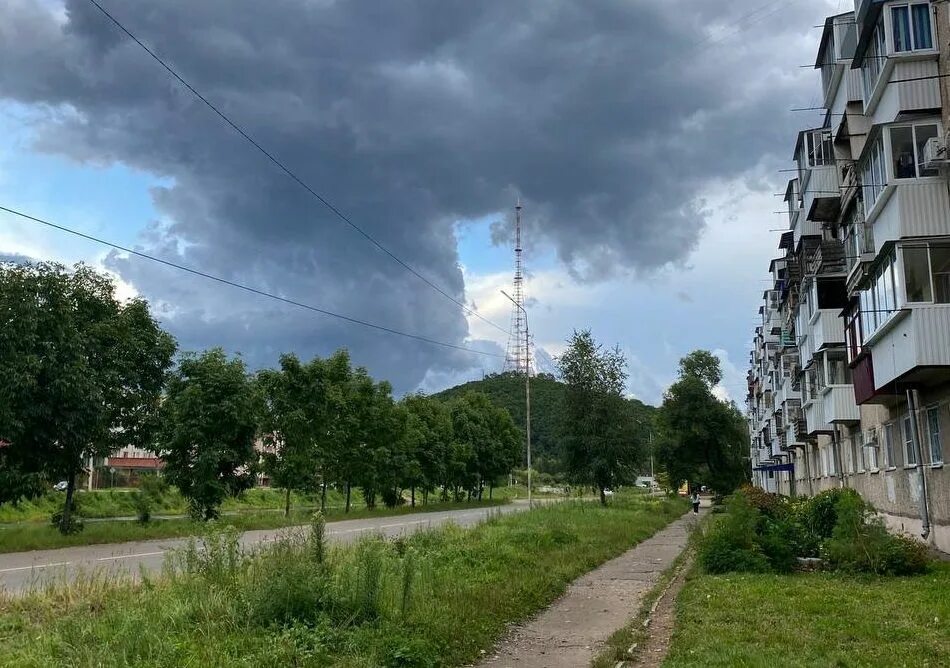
<box><xmin>558</xmin><ymin>330</ymin><xmax>639</xmax><ymax>505</ymax></box>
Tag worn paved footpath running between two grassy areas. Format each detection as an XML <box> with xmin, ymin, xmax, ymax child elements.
<box><xmin>479</xmin><ymin>504</ymin><xmax>708</xmax><ymax>668</ymax></box>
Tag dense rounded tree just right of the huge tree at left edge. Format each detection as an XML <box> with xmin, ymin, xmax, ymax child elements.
<box><xmin>157</xmin><ymin>348</ymin><xmax>257</xmax><ymax>520</ymax></box>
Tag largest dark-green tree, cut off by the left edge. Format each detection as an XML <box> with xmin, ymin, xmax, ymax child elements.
<box><xmin>0</xmin><ymin>263</ymin><xmax>175</xmax><ymax>531</ymax></box>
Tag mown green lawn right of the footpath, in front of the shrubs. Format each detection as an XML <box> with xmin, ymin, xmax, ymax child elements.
<box><xmin>663</xmin><ymin>563</ymin><xmax>950</xmax><ymax>668</ymax></box>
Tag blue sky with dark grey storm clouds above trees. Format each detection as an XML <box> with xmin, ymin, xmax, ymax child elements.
<box><xmin>0</xmin><ymin>0</ymin><xmax>852</xmax><ymax>404</ymax></box>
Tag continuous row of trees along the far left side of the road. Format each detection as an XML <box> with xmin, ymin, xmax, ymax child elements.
<box><xmin>0</xmin><ymin>263</ymin><xmax>522</xmax><ymax>531</ymax></box>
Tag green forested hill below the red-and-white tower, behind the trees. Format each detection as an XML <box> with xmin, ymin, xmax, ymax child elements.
<box><xmin>434</xmin><ymin>373</ymin><xmax>656</xmax><ymax>473</ymax></box>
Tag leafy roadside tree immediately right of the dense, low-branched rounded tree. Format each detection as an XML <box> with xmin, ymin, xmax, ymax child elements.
<box><xmin>256</xmin><ymin>354</ymin><xmax>328</xmax><ymax>517</ymax></box>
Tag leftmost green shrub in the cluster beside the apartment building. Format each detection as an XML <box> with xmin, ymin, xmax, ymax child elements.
<box><xmin>699</xmin><ymin>491</ymin><xmax>769</xmax><ymax>573</ymax></box>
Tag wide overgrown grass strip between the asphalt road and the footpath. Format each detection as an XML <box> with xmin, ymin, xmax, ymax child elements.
<box><xmin>0</xmin><ymin>496</ymin><xmax>685</xmax><ymax>668</ymax></box>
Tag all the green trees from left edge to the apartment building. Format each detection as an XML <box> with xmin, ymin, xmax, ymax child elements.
<box><xmin>0</xmin><ymin>263</ymin><xmax>748</xmax><ymax>531</ymax></box>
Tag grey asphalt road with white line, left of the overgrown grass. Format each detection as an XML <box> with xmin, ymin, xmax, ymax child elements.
<box><xmin>0</xmin><ymin>501</ymin><xmax>528</xmax><ymax>592</ymax></box>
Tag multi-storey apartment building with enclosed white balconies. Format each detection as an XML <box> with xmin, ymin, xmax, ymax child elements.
<box><xmin>748</xmin><ymin>0</ymin><xmax>950</xmax><ymax>551</ymax></box>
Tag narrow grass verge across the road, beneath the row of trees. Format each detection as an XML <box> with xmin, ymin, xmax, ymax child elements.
<box><xmin>0</xmin><ymin>500</ymin><xmax>505</xmax><ymax>554</ymax></box>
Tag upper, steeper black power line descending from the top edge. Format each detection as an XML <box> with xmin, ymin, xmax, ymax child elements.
<box><xmin>89</xmin><ymin>0</ymin><xmax>508</xmax><ymax>334</ymax></box>
